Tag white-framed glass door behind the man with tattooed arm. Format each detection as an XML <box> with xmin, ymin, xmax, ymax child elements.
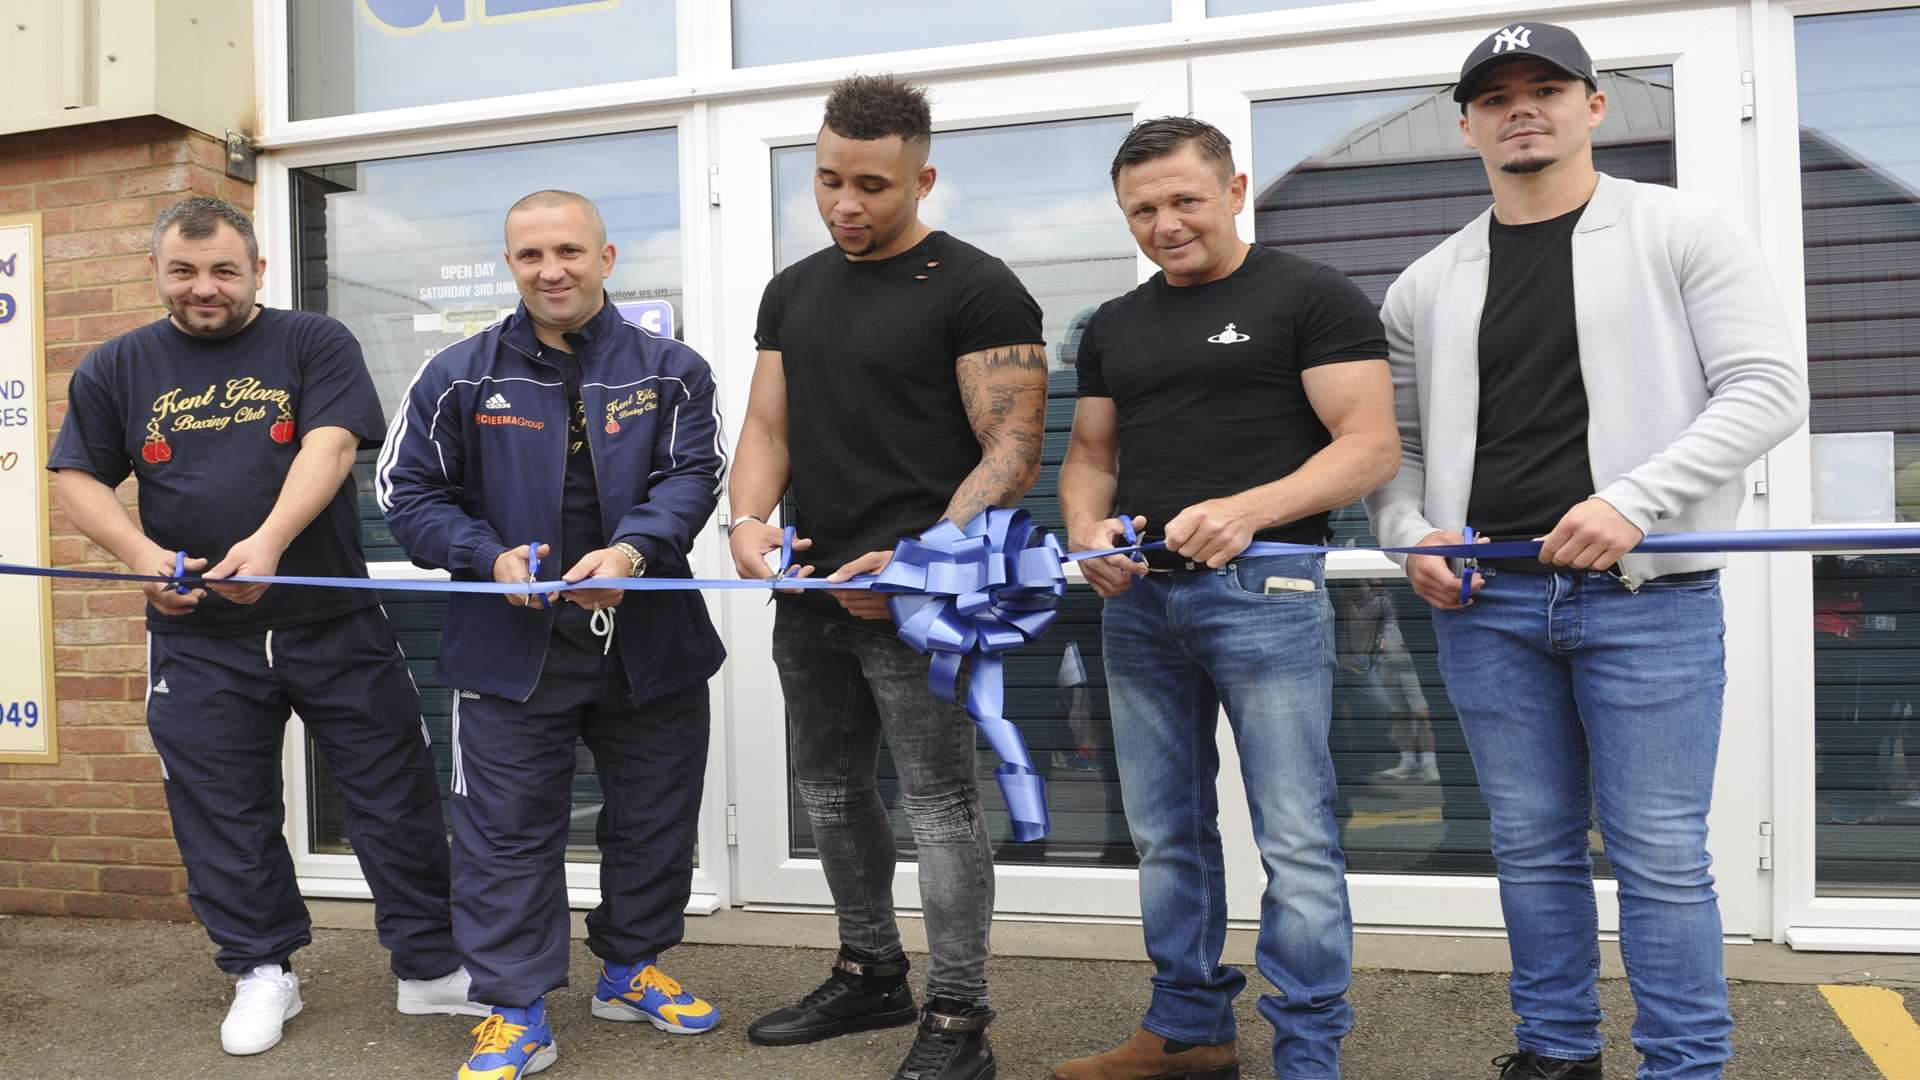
<box><xmin>716</xmin><ymin>61</ymin><xmax>1250</xmax><ymax>917</ymax></box>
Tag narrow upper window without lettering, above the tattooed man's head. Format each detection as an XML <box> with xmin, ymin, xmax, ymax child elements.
<box><xmin>733</xmin><ymin>0</ymin><xmax>1173</xmax><ymax>67</ymax></box>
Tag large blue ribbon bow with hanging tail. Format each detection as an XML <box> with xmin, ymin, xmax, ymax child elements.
<box><xmin>872</xmin><ymin>507</ymin><xmax>1066</xmax><ymax>840</ymax></box>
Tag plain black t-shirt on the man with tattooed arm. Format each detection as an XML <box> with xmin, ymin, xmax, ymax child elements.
<box><xmin>755</xmin><ymin>233</ymin><xmax>1044</xmax><ymax>617</ymax></box>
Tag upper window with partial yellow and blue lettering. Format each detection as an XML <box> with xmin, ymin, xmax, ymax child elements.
<box><xmin>286</xmin><ymin>0</ymin><xmax>676</xmax><ymax>119</ymax></box>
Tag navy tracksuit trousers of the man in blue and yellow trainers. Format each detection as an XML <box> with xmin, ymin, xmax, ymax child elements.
<box><xmin>449</xmin><ymin>601</ymin><xmax>710</xmax><ymax>1009</ymax></box>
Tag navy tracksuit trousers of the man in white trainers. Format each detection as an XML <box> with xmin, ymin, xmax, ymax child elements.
<box><xmin>146</xmin><ymin>607</ymin><xmax>461</xmax><ymax>978</ymax></box>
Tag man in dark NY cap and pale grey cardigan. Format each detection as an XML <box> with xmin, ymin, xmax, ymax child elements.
<box><xmin>1367</xmin><ymin>23</ymin><xmax>1807</xmax><ymax>1080</ymax></box>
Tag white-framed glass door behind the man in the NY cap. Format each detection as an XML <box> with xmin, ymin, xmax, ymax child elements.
<box><xmin>1192</xmin><ymin>2</ymin><xmax>1766</xmax><ymax>936</ymax></box>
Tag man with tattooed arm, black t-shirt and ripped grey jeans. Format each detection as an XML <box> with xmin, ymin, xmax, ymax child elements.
<box><xmin>732</xmin><ymin>77</ymin><xmax>1046</xmax><ymax>1080</ymax></box>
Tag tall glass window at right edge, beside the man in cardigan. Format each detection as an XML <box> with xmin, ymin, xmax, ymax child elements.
<box><xmin>1793</xmin><ymin>10</ymin><xmax>1920</xmax><ymax>896</ymax></box>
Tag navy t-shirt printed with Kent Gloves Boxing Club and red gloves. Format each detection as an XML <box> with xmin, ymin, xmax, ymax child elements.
<box><xmin>48</xmin><ymin>307</ymin><xmax>386</xmax><ymax>634</ymax></box>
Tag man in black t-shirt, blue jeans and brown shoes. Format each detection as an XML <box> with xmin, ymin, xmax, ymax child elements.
<box><xmin>1054</xmin><ymin>117</ymin><xmax>1400</xmax><ymax>1080</ymax></box>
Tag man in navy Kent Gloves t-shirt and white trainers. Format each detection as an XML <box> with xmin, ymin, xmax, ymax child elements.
<box><xmin>48</xmin><ymin>196</ymin><xmax>484</xmax><ymax>1053</ymax></box>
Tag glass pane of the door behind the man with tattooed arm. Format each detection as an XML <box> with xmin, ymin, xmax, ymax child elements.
<box><xmin>772</xmin><ymin>117</ymin><xmax>1137</xmax><ymax>867</ymax></box>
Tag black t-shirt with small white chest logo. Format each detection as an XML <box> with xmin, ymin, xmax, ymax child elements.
<box><xmin>1077</xmin><ymin>244</ymin><xmax>1386</xmax><ymax>544</ymax></box>
